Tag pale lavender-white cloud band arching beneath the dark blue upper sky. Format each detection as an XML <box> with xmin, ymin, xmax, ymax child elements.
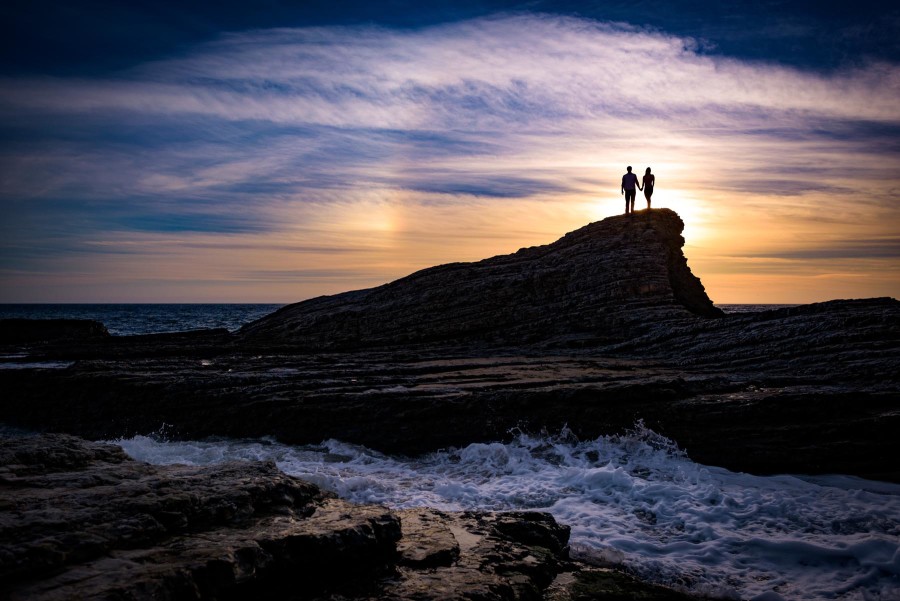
<box><xmin>0</xmin><ymin>16</ymin><xmax>900</xmax><ymax>129</ymax></box>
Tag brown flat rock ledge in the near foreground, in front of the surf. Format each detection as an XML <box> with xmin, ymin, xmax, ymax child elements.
<box><xmin>0</xmin><ymin>434</ymin><xmax>700</xmax><ymax>601</ymax></box>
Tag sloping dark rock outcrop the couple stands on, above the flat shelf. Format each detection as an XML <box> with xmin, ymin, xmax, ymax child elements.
<box><xmin>239</xmin><ymin>209</ymin><xmax>721</xmax><ymax>350</ymax></box>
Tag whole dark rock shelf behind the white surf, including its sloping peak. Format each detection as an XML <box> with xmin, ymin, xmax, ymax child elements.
<box><xmin>0</xmin><ymin>210</ymin><xmax>900</xmax><ymax>481</ymax></box>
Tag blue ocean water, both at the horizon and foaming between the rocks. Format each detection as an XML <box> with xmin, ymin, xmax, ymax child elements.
<box><xmin>0</xmin><ymin>305</ymin><xmax>900</xmax><ymax>601</ymax></box>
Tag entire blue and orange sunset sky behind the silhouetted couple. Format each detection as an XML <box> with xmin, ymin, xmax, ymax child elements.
<box><xmin>0</xmin><ymin>0</ymin><xmax>900</xmax><ymax>304</ymax></box>
